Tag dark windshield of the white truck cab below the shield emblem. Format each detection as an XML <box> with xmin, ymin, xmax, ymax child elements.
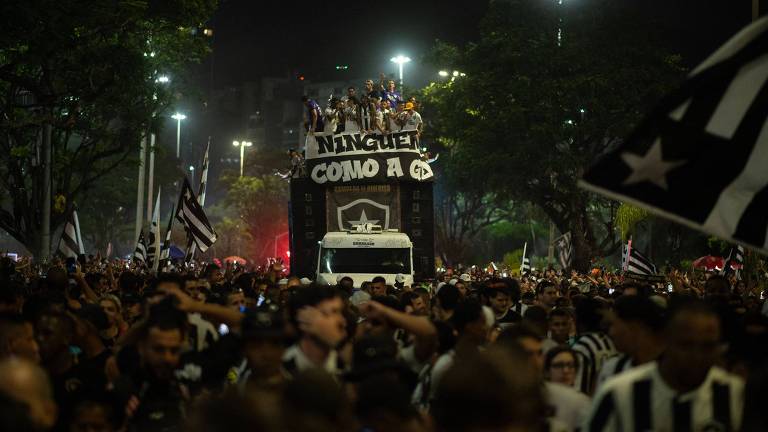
<box><xmin>320</xmin><ymin>248</ymin><xmax>411</xmax><ymax>274</ymax></box>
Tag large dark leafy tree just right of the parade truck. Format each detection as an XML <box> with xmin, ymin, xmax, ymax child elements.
<box><xmin>423</xmin><ymin>0</ymin><xmax>682</xmax><ymax>269</ymax></box>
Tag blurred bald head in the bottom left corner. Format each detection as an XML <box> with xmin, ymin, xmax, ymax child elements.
<box><xmin>0</xmin><ymin>358</ymin><xmax>57</xmax><ymax>429</ymax></box>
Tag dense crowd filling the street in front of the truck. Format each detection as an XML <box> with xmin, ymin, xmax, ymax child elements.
<box><xmin>0</xmin><ymin>258</ymin><xmax>768</xmax><ymax>432</ymax></box>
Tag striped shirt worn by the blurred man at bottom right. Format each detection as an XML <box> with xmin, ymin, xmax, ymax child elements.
<box><xmin>582</xmin><ymin>362</ymin><xmax>744</xmax><ymax>432</ymax></box>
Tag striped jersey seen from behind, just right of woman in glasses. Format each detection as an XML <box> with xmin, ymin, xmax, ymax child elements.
<box><xmin>571</xmin><ymin>332</ymin><xmax>617</xmax><ymax>395</ymax></box>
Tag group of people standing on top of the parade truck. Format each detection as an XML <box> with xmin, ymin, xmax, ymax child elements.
<box><xmin>301</xmin><ymin>74</ymin><xmax>424</xmax><ymax>136</ymax></box>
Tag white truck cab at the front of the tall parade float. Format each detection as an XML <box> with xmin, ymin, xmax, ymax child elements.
<box><xmin>317</xmin><ymin>223</ymin><xmax>414</xmax><ymax>287</ymax></box>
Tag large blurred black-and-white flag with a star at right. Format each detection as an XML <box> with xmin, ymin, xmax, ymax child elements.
<box><xmin>580</xmin><ymin>17</ymin><xmax>768</xmax><ymax>252</ymax></box>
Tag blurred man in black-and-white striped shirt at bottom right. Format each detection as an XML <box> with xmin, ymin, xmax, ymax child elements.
<box><xmin>585</xmin><ymin>302</ymin><xmax>744</xmax><ymax>431</ymax></box>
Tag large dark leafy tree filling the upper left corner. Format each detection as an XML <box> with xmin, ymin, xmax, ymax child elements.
<box><xmin>0</xmin><ymin>0</ymin><xmax>216</xmax><ymax>253</ymax></box>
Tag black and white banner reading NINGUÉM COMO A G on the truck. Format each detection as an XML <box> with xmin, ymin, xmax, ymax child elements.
<box><xmin>306</xmin><ymin>131</ymin><xmax>433</xmax><ymax>184</ymax></box>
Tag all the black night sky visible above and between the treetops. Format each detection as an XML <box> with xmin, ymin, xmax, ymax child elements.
<box><xmin>203</xmin><ymin>0</ymin><xmax>768</xmax><ymax>88</ymax></box>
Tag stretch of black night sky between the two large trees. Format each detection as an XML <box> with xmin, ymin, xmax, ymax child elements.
<box><xmin>204</xmin><ymin>0</ymin><xmax>488</xmax><ymax>87</ymax></box>
